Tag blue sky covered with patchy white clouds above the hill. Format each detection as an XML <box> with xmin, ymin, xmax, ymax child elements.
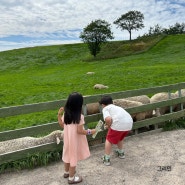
<box><xmin>0</xmin><ymin>0</ymin><xmax>185</xmax><ymax>51</ymax></box>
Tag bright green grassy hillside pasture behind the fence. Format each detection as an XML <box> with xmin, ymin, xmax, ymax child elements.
<box><xmin>0</xmin><ymin>34</ymin><xmax>185</xmax><ymax>132</ymax></box>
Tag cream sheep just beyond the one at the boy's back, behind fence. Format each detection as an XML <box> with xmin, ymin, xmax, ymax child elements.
<box><xmin>125</xmin><ymin>95</ymin><xmax>153</xmax><ymax>118</ymax></box>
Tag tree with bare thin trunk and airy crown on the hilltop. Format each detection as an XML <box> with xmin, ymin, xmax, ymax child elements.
<box><xmin>114</xmin><ymin>11</ymin><xmax>144</xmax><ymax>40</ymax></box>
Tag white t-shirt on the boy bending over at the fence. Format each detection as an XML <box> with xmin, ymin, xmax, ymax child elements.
<box><xmin>102</xmin><ymin>104</ymin><xmax>133</xmax><ymax>131</ymax></box>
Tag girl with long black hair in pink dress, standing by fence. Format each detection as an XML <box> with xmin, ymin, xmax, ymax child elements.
<box><xmin>58</xmin><ymin>92</ymin><xmax>96</xmax><ymax>184</ymax></box>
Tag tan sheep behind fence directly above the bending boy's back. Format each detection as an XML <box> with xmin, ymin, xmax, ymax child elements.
<box><xmin>113</xmin><ymin>99</ymin><xmax>146</xmax><ymax>121</ymax></box>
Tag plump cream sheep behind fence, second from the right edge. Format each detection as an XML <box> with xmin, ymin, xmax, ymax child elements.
<box><xmin>150</xmin><ymin>92</ymin><xmax>177</xmax><ymax>116</ymax></box>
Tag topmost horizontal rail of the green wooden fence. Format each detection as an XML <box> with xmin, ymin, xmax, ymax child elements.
<box><xmin>0</xmin><ymin>83</ymin><xmax>185</xmax><ymax>117</ymax></box>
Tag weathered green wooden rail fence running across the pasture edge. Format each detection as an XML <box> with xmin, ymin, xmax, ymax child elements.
<box><xmin>0</xmin><ymin>82</ymin><xmax>185</xmax><ymax>165</ymax></box>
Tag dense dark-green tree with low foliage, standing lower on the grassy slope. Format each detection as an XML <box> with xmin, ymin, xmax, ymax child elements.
<box><xmin>80</xmin><ymin>19</ymin><xmax>114</xmax><ymax>57</ymax></box>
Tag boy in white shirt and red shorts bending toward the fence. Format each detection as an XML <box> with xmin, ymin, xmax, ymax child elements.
<box><xmin>99</xmin><ymin>96</ymin><xmax>133</xmax><ymax>166</ymax></box>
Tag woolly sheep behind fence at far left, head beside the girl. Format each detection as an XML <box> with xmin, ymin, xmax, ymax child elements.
<box><xmin>0</xmin><ymin>130</ymin><xmax>63</xmax><ymax>154</ymax></box>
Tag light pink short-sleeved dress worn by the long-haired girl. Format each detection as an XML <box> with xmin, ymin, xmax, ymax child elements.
<box><xmin>62</xmin><ymin>115</ymin><xmax>90</xmax><ymax>167</ymax></box>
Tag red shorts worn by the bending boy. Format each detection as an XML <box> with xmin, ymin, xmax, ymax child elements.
<box><xmin>106</xmin><ymin>128</ymin><xmax>129</xmax><ymax>144</ymax></box>
